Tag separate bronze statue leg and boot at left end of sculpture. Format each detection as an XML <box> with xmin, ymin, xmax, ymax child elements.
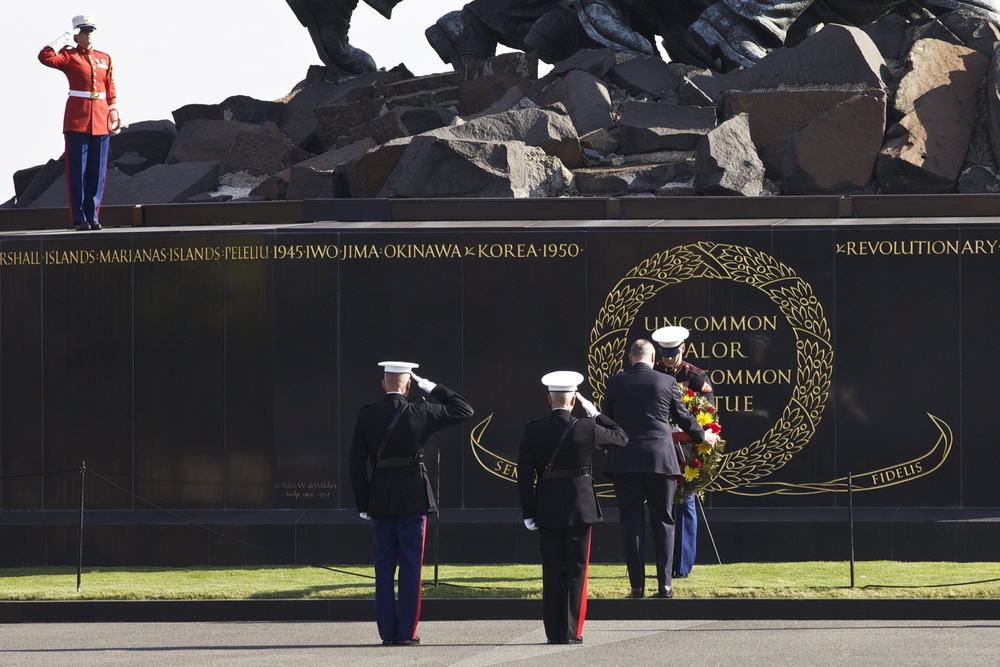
<box><xmin>286</xmin><ymin>0</ymin><xmax>402</xmax><ymax>78</ymax></box>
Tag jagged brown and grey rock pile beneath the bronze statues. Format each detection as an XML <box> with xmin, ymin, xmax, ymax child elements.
<box><xmin>5</xmin><ymin>6</ymin><xmax>1000</xmax><ymax>207</ymax></box>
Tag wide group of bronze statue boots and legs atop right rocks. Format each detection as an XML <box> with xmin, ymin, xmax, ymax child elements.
<box><xmin>426</xmin><ymin>0</ymin><xmax>1000</xmax><ymax>72</ymax></box>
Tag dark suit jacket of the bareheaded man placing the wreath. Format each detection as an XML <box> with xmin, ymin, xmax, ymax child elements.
<box><xmin>601</xmin><ymin>362</ymin><xmax>705</xmax><ymax>476</ymax></box>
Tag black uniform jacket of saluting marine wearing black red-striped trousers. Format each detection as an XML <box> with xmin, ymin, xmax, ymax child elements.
<box><xmin>517</xmin><ymin>410</ymin><xmax>628</xmax><ymax>528</ymax></box>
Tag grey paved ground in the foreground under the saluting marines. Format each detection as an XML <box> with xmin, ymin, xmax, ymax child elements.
<box><xmin>0</xmin><ymin>621</ymin><xmax>1000</xmax><ymax>667</ymax></box>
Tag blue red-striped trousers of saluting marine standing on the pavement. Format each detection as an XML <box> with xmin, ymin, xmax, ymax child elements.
<box><xmin>372</xmin><ymin>514</ymin><xmax>427</xmax><ymax>641</ymax></box>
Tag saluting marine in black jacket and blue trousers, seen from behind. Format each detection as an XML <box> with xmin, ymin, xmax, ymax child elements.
<box><xmin>350</xmin><ymin>361</ymin><xmax>472</xmax><ymax>646</ymax></box>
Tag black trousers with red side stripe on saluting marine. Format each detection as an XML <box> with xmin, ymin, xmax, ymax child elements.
<box><xmin>538</xmin><ymin>524</ymin><xmax>591</xmax><ymax>643</ymax></box>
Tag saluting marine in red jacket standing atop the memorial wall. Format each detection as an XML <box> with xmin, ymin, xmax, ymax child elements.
<box><xmin>38</xmin><ymin>15</ymin><xmax>121</xmax><ymax>230</ymax></box>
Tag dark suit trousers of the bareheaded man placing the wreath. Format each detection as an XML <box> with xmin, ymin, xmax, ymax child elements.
<box><xmin>612</xmin><ymin>473</ymin><xmax>677</xmax><ymax>588</ymax></box>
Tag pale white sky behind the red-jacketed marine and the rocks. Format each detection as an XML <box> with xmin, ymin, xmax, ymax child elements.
<box><xmin>0</xmin><ymin>0</ymin><xmax>480</xmax><ymax>203</ymax></box>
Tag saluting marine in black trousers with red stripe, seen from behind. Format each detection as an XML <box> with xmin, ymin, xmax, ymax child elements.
<box><xmin>517</xmin><ymin>371</ymin><xmax>628</xmax><ymax>644</ymax></box>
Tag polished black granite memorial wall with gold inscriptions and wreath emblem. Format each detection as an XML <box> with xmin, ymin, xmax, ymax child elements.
<box><xmin>0</xmin><ymin>222</ymin><xmax>1000</xmax><ymax>564</ymax></box>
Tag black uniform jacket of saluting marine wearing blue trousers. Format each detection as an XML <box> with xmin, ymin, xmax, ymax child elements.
<box><xmin>350</xmin><ymin>384</ymin><xmax>472</xmax><ymax>517</ymax></box>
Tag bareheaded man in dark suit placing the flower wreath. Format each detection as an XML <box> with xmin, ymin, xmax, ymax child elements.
<box><xmin>603</xmin><ymin>339</ymin><xmax>718</xmax><ymax>598</ymax></box>
